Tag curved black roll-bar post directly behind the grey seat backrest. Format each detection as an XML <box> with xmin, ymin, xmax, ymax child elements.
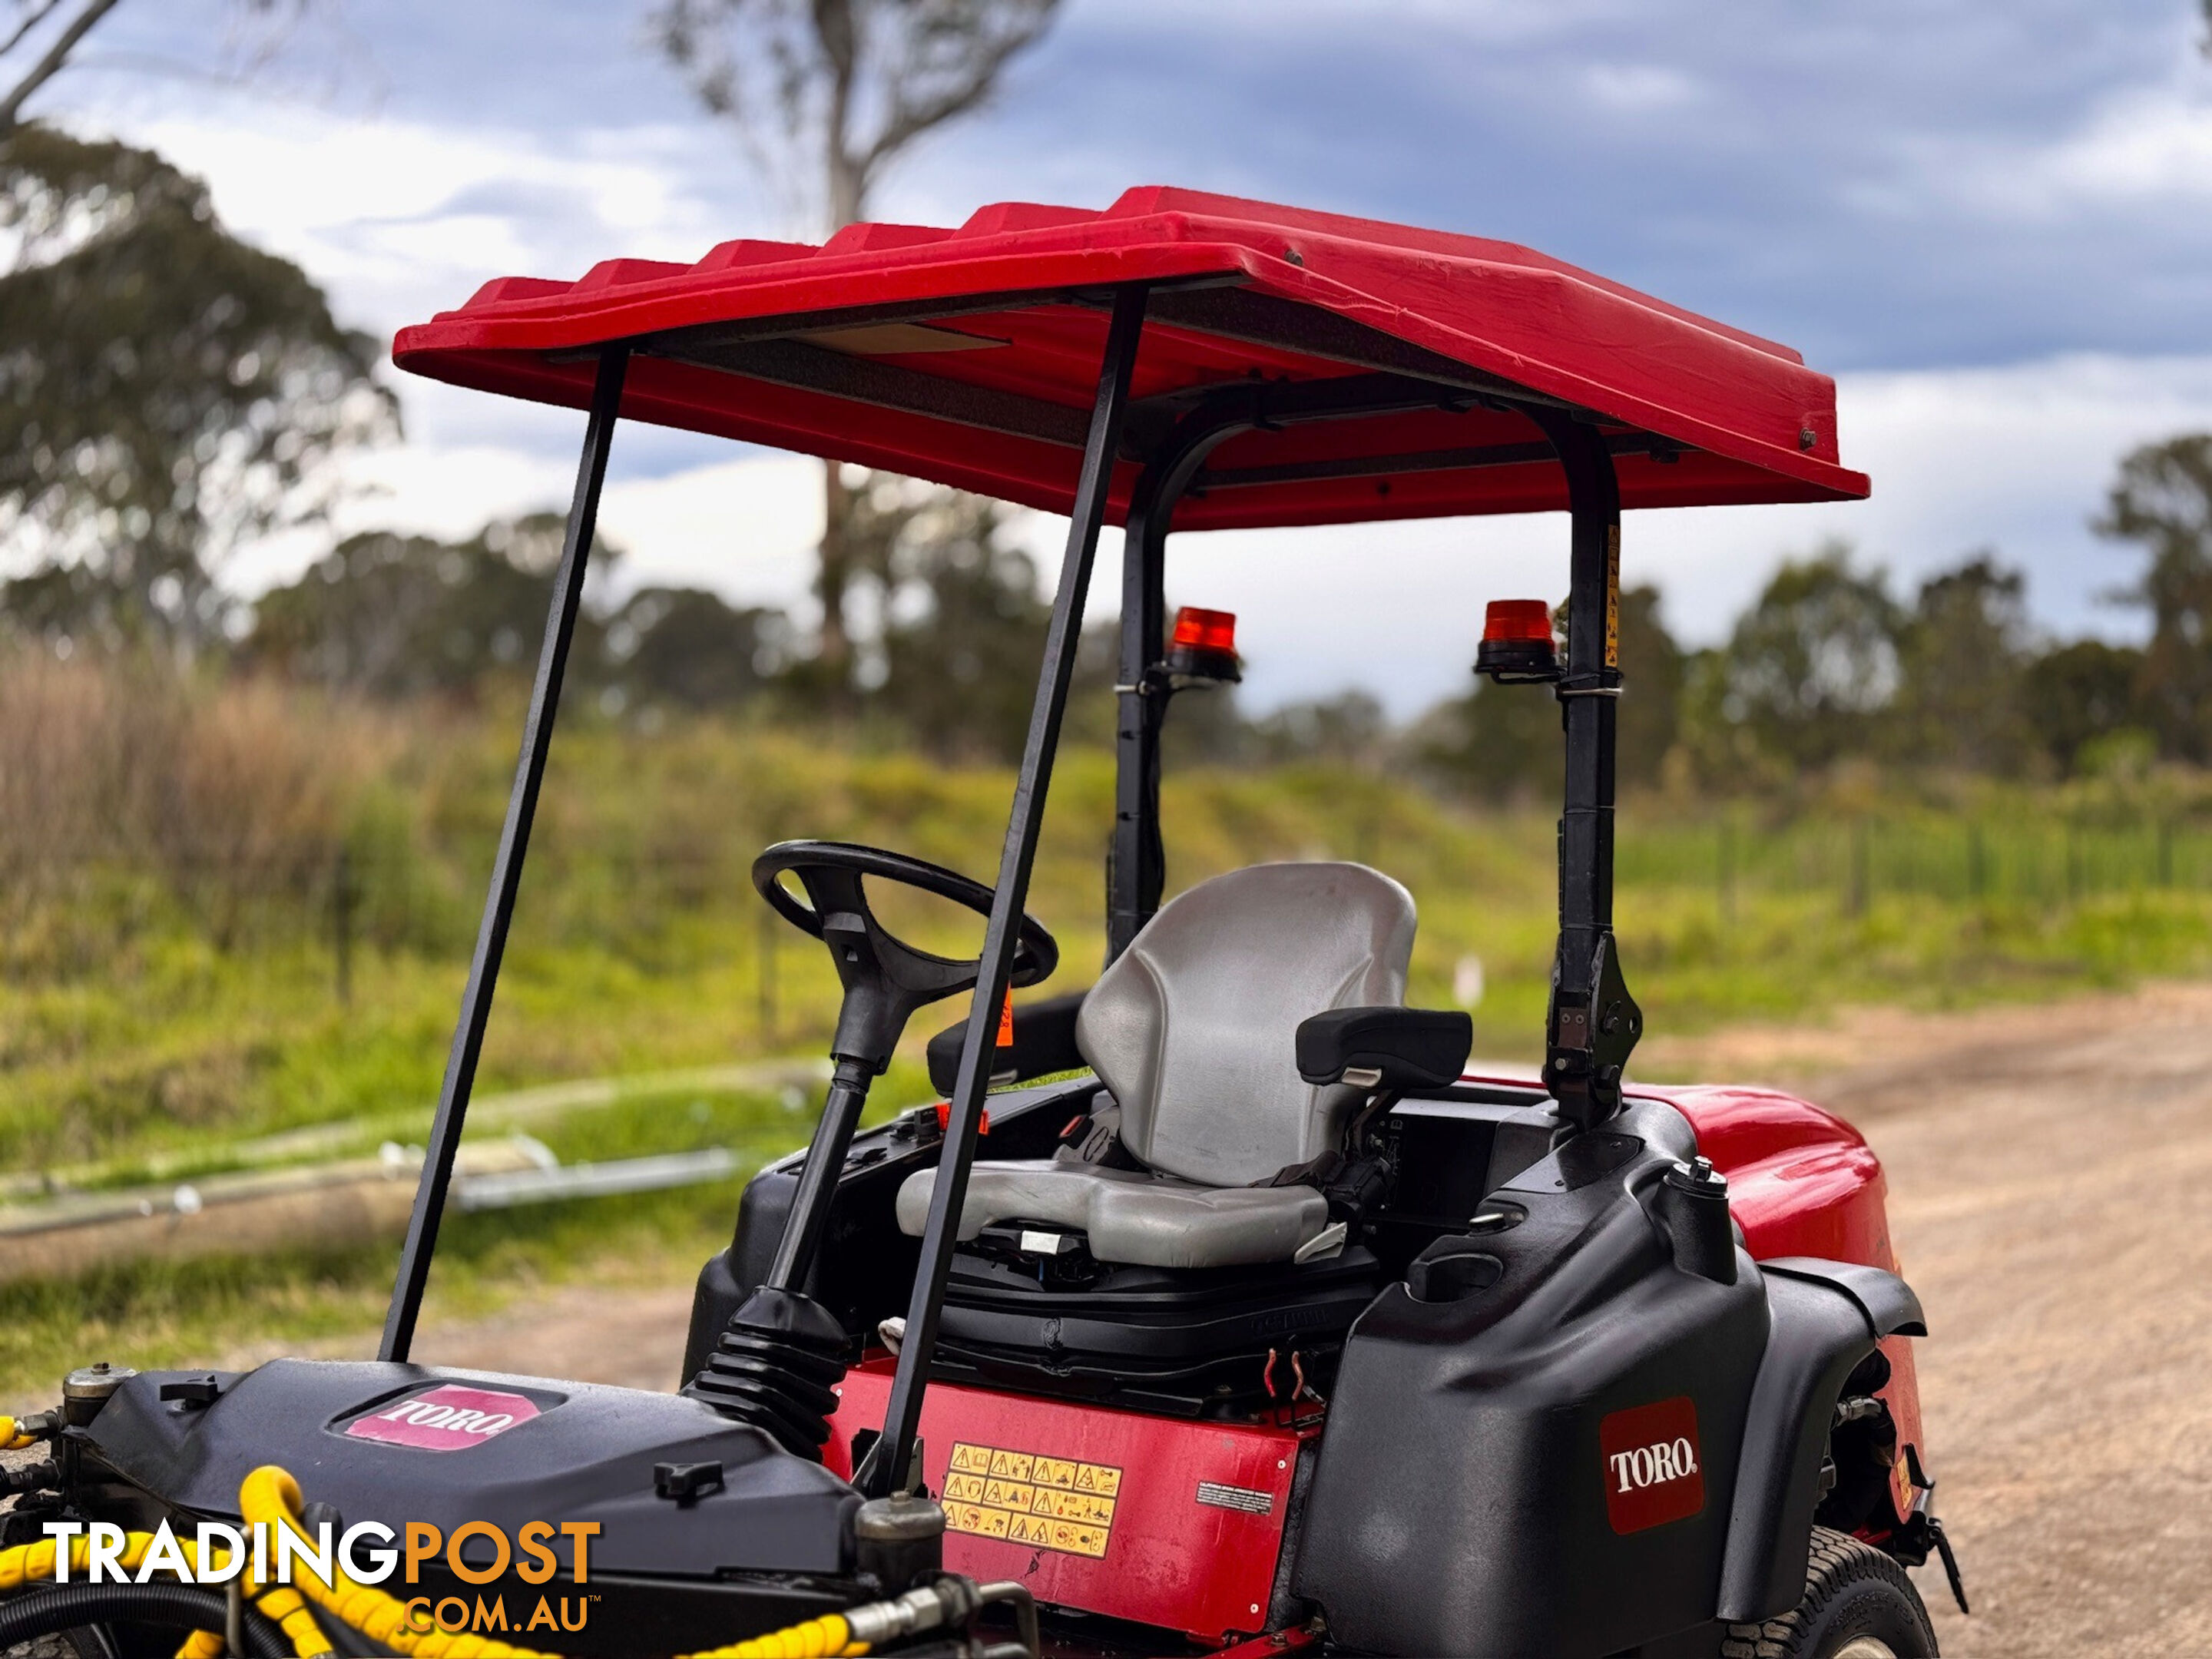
<box><xmin>1106</xmin><ymin>412</ymin><xmax>1254</xmax><ymax>965</ymax></box>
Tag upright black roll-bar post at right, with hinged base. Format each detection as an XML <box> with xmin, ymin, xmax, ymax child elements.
<box><xmin>1528</xmin><ymin>409</ymin><xmax>1644</xmax><ymax>1128</ymax></box>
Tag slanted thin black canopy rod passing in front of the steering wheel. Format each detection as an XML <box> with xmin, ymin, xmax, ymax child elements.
<box><xmin>867</xmin><ymin>283</ymin><xmax>1146</xmax><ymax>1498</ymax></box>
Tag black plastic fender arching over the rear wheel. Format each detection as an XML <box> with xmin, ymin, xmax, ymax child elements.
<box><xmin>1719</xmin><ymin>1257</ymin><xmax>1926</xmax><ymax>1624</ymax></box>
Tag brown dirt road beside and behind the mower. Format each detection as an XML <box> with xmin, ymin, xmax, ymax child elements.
<box><xmin>160</xmin><ymin>985</ymin><xmax>2212</xmax><ymax>1659</ymax></box>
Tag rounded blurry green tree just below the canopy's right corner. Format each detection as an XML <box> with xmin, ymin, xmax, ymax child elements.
<box><xmin>1719</xmin><ymin>542</ymin><xmax>1902</xmax><ymax>767</ymax></box>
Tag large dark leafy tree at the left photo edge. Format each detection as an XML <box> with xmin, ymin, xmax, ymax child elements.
<box><xmin>0</xmin><ymin>124</ymin><xmax>398</xmax><ymax>646</ymax></box>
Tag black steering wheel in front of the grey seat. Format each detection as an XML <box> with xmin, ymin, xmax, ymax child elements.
<box><xmin>752</xmin><ymin>840</ymin><xmax>1060</xmax><ymax>1073</ymax></box>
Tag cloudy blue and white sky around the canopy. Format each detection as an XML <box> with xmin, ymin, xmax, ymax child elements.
<box><xmin>33</xmin><ymin>0</ymin><xmax>2212</xmax><ymax>712</ymax></box>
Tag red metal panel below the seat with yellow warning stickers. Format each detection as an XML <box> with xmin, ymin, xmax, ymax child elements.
<box><xmin>823</xmin><ymin>1360</ymin><xmax>1299</xmax><ymax>1641</ymax></box>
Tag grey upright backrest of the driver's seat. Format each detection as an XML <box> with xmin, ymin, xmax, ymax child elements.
<box><xmin>1075</xmin><ymin>865</ymin><xmax>1413</xmax><ymax>1186</ymax></box>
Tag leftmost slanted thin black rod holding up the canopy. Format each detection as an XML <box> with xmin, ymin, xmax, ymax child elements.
<box><xmin>376</xmin><ymin>345</ymin><xmax>631</xmax><ymax>1360</ymax></box>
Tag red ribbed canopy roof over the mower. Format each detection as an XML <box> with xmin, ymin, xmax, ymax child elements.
<box><xmin>392</xmin><ymin>186</ymin><xmax>1867</xmax><ymax>528</ymax></box>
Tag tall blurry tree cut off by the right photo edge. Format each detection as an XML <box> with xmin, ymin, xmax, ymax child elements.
<box><xmin>2094</xmin><ymin>432</ymin><xmax>2212</xmax><ymax>765</ymax></box>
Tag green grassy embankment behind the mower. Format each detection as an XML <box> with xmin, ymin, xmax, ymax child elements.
<box><xmin>12</xmin><ymin>667</ymin><xmax>2212</xmax><ymax>1396</ymax></box>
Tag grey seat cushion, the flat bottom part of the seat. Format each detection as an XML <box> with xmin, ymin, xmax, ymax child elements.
<box><xmin>898</xmin><ymin>1159</ymin><xmax>1330</xmax><ymax>1267</ymax></box>
